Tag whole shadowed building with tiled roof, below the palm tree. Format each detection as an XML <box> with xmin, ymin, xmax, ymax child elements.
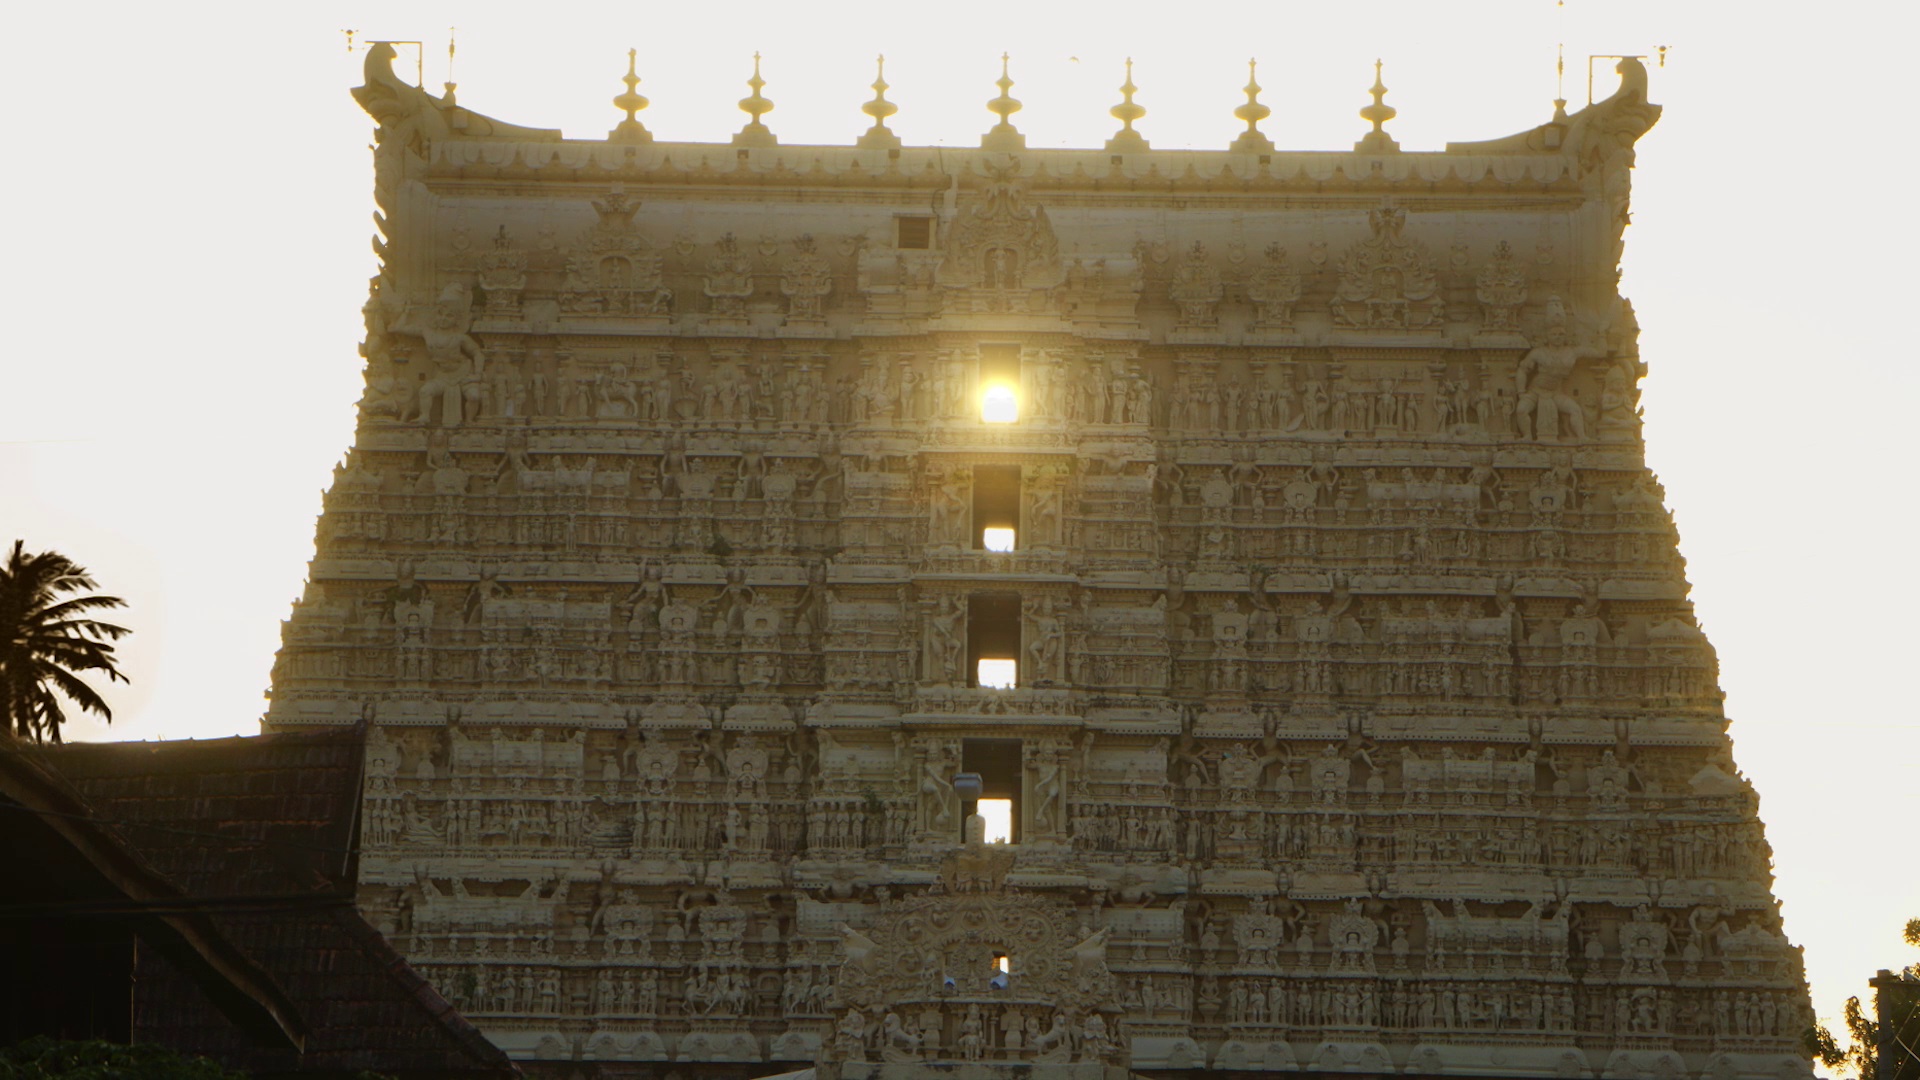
<box><xmin>0</xmin><ymin>728</ymin><xmax>516</xmax><ymax>1080</ymax></box>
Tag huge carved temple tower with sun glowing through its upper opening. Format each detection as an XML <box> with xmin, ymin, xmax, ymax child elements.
<box><xmin>267</xmin><ymin>44</ymin><xmax>1811</xmax><ymax>1080</ymax></box>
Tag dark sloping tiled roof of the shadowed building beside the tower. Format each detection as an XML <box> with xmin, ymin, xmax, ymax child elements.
<box><xmin>42</xmin><ymin>728</ymin><xmax>516</xmax><ymax>1078</ymax></box>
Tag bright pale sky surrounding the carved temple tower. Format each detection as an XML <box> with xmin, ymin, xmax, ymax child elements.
<box><xmin>0</xmin><ymin>0</ymin><xmax>1920</xmax><ymax>1053</ymax></box>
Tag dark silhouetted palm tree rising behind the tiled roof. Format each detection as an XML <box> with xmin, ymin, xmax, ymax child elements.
<box><xmin>0</xmin><ymin>540</ymin><xmax>131</xmax><ymax>742</ymax></box>
